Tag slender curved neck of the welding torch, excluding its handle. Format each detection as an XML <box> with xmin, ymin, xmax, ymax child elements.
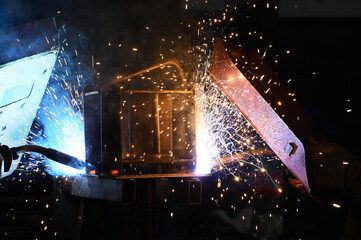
<box><xmin>11</xmin><ymin>145</ymin><xmax>85</xmax><ymax>170</ymax></box>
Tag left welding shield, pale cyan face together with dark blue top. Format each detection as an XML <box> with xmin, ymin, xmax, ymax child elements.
<box><xmin>0</xmin><ymin>19</ymin><xmax>59</xmax><ymax>178</ymax></box>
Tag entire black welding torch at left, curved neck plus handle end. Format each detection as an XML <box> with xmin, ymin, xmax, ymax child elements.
<box><xmin>0</xmin><ymin>145</ymin><xmax>86</xmax><ymax>178</ymax></box>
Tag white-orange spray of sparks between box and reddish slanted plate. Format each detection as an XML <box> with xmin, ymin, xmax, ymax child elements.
<box><xmin>196</xmin><ymin>61</ymin><xmax>281</xmax><ymax>189</ymax></box>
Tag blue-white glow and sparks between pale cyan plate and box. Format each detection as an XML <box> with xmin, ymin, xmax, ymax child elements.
<box><xmin>20</xmin><ymin>26</ymin><xmax>89</xmax><ymax>175</ymax></box>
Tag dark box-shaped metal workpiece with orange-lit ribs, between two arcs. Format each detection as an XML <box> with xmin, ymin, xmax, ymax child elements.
<box><xmin>84</xmin><ymin>60</ymin><xmax>196</xmax><ymax>179</ymax></box>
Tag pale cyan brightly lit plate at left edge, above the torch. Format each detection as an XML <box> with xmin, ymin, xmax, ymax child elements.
<box><xmin>0</xmin><ymin>50</ymin><xmax>57</xmax><ymax>177</ymax></box>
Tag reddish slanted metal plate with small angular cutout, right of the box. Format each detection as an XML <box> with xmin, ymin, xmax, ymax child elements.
<box><xmin>208</xmin><ymin>39</ymin><xmax>310</xmax><ymax>192</ymax></box>
